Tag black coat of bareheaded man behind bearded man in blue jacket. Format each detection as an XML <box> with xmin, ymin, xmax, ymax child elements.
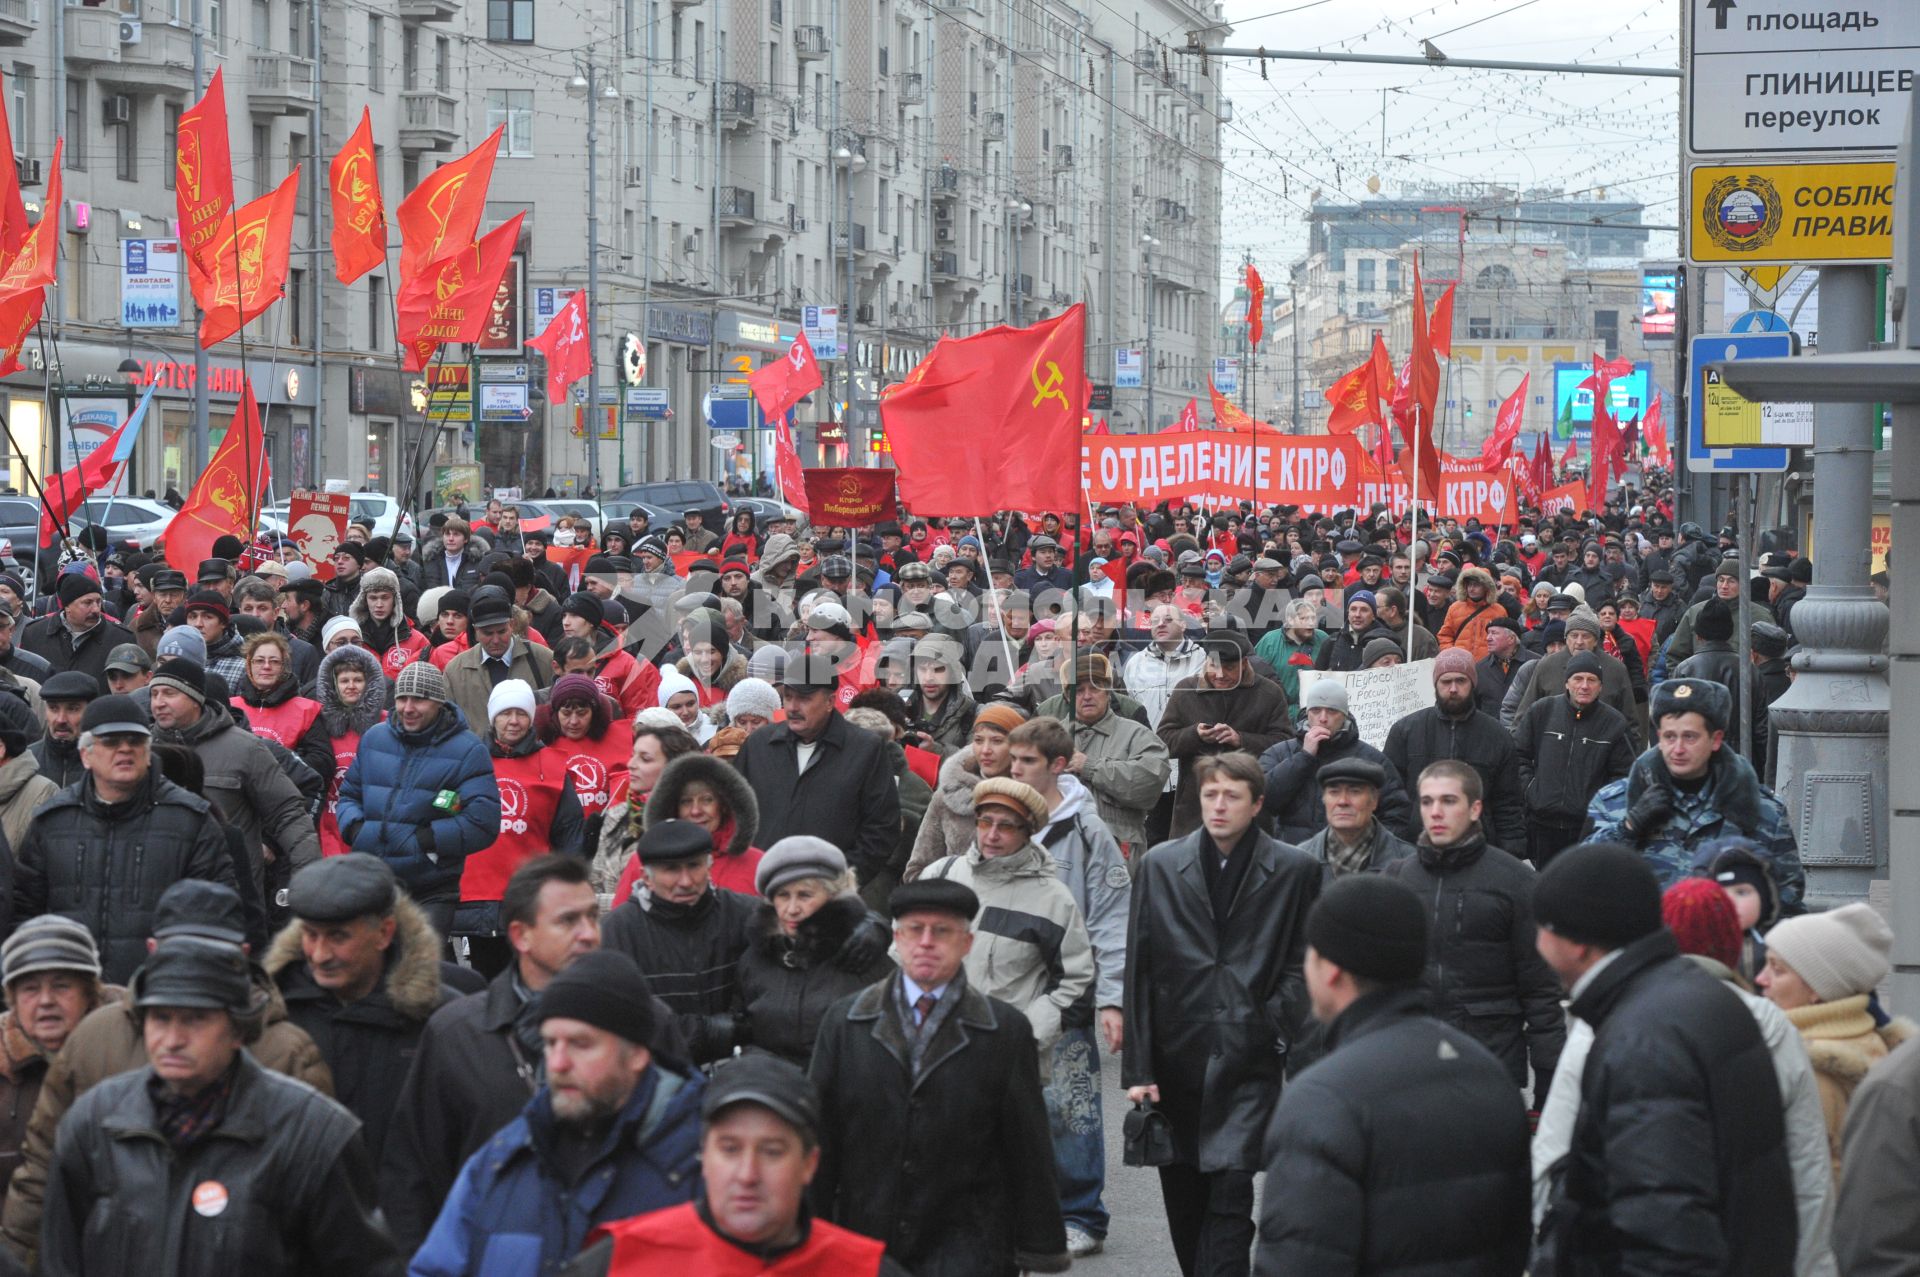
<box><xmin>380</xmin><ymin>968</ymin><xmax>687</xmax><ymax>1254</ymax></box>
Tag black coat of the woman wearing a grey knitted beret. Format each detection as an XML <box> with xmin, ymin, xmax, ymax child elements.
<box><xmin>739</xmin><ymin>895</ymin><xmax>895</xmax><ymax>1068</ymax></box>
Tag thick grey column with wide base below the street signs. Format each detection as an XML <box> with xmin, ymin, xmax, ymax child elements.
<box><xmin>1772</xmin><ymin>267</ymin><xmax>1889</xmax><ymax>910</ymax></box>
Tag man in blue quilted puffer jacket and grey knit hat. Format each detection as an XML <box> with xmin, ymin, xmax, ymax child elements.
<box><xmin>338</xmin><ymin>661</ymin><xmax>499</xmax><ymax>935</ymax></box>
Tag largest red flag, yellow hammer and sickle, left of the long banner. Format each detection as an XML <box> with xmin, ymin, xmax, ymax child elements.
<box><xmin>879</xmin><ymin>303</ymin><xmax>1087</xmax><ymax>517</ymax></box>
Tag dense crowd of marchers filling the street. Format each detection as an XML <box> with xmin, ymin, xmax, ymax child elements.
<box><xmin>0</xmin><ymin>480</ymin><xmax>1896</xmax><ymax>1277</ymax></box>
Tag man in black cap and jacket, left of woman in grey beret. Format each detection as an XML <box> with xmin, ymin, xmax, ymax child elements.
<box><xmin>601</xmin><ymin>820</ymin><xmax>756</xmax><ymax>1064</ymax></box>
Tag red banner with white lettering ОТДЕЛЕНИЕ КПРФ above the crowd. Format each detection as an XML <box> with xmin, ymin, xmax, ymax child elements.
<box><xmin>1081</xmin><ymin>434</ymin><xmax>1359</xmax><ymax>507</ymax></box>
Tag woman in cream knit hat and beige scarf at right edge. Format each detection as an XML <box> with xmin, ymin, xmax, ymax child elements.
<box><xmin>1757</xmin><ymin>904</ymin><xmax>1914</xmax><ymax>1175</ymax></box>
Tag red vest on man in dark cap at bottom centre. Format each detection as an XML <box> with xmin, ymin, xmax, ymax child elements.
<box><xmin>588</xmin><ymin>1204</ymin><xmax>887</xmax><ymax>1277</ymax></box>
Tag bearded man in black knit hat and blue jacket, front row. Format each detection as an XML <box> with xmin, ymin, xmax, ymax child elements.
<box><xmin>407</xmin><ymin>952</ymin><xmax>707</xmax><ymax>1277</ymax></box>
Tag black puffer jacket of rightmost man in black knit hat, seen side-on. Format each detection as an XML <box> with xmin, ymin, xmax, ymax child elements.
<box><xmin>1534</xmin><ymin>929</ymin><xmax>1797</xmax><ymax>1277</ymax></box>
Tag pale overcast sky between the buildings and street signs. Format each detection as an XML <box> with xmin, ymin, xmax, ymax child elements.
<box><xmin>1215</xmin><ymin>0</ymin><xmax>1695</xmax><ymax>296</ymax></box>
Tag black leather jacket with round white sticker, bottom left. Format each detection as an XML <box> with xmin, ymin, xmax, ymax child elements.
<box><xmin>40</xmin><ymin>1052</ymin><xmax>403</xmax><ymax>1277</ymax></box>
